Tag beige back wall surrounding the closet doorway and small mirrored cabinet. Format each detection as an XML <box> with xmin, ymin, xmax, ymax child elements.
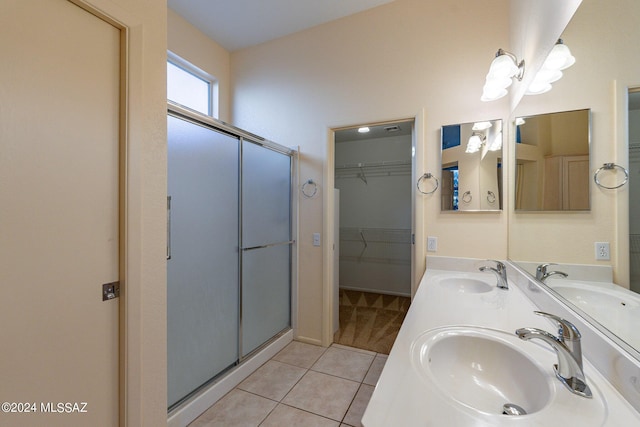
<box><xmin>231</xmin><ymin>0</ymin><xmax>509</xmax><ymax>341</ymax></box>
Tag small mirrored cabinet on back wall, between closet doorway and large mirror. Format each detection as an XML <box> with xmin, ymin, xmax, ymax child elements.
<box><xmin>440</xmin><ymin>120</ymin><xmax>502</xmax><ymax>212</ymax></box>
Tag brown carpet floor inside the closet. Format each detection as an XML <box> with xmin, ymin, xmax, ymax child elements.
<box><xmin>333</xmin><ymin>289</ymin><xmax>411</xmax><ymax>354</ymax></box>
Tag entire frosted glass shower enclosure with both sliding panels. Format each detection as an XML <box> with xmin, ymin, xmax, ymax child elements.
<box><xmin>167</xmin><ymin>104</ymin><xmax>294</xmax><ymax>410</ymax></box>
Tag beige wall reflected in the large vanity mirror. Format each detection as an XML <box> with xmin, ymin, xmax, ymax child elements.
<box><xmin>509</xmin><ymin>0</ymin><xmax>640</xmax><ymax>285</ymax></box>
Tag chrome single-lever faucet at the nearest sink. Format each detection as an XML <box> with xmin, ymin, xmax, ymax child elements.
<box><xmin>516</xmin><ymin>311</ymin><xmax>592</xmax><ymax>398</ymax></box>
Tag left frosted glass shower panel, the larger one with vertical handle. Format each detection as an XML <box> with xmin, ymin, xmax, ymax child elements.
<box><xmin>167</xmin><ymin>116</ymin><xmax>239</xmax><ymax>407</ymax></box>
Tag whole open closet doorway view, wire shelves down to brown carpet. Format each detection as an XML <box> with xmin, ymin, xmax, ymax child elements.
<box><xmin>334</xmin><ymin>121</ymin><xmax>414</xmax><ymax>354</ymax></box>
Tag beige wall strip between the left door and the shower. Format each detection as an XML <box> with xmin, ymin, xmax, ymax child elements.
<box><xmin>95</xmin><ymin>0</ymin><xmax>167</xmax><ymax>427</ymax></box>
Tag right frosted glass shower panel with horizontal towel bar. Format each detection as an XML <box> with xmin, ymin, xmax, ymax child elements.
<box><xmin>241</xmin><ymin>141</ymin><xmax>291</xmax><ymax>356</ymax></box>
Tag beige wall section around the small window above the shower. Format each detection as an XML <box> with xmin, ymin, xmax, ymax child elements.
<box><xmin>167</xmin><ymin>9</ymin><xmax>231</xmax><ymax>123</ymax></box>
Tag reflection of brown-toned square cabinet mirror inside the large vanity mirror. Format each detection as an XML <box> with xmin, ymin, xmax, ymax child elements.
<box><xmin>515</xmin><ymin>109</ymin><xmax>590</xmax><ymax>211</ymax></box>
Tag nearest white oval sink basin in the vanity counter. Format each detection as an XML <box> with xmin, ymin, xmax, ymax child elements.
<box><xmin>411</xmin><ymin>327</ymin><xmax>552</xmax><ymax>414</ymax></box>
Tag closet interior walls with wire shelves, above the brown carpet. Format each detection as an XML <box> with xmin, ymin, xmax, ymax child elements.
<box><xmin>335</xmin><ymin>122</ymin><xmax>412</xmax><ymax>296</ymax></box>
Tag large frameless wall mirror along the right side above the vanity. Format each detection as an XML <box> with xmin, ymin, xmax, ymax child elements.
<box><xmin>508</xmin><ymin>0</ymin><xmax>640</xmax><ymax>360</ymax></box>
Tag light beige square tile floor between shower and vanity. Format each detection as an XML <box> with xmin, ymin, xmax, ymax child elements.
<box><xmin>190</xmin><ymin>341</ymin><xmax>387</xmax><ymax>427</ymax></box>
